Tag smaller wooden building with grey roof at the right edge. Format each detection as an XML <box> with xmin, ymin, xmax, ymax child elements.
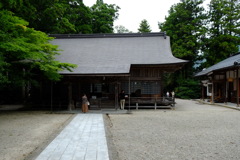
<box><xmin>195</xmin><ymin>53</ymin><xmax>240</xmax><ymax>106</ymax></box>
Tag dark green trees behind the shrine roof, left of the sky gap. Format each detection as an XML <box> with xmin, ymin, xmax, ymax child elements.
<box><xmin>0</xmin><ymin>0</ymin><xmax>120</xmax><ymax>34</ymax></box>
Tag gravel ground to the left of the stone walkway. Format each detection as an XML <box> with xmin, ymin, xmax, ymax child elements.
<box><xmin>0</xmin><ymin>111</ymin><xmax>73</xmax><ymax>160</ymax></box>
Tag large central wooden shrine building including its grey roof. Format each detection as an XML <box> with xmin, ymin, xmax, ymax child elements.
<box><xmin>46</xmin><ymin>32</ymin><xmax>187</xmax><ymax>109</ymax></box>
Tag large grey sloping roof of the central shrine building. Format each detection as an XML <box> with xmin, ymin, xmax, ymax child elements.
<box><xmin>51</xmin><ymin>33</ymin><xmax>187</xmax><ymax>74</ymax></box>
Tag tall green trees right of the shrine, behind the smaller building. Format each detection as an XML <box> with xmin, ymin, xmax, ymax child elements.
<box><xmin>159</xmin><ymin>0</ymin><xmax>240</xmax><ymax>98</ymax></box>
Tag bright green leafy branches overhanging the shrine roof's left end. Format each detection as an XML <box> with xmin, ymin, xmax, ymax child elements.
<box><xmin>0</xmin><ymin>10</ymin><xmax>75</xmax><ymax>85</ymax></box>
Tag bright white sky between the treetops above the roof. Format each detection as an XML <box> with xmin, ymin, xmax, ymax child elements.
<box><xmin>83</xmin><ymin>0</ymin><xmax>210</xmax><ymax>32</ymax></box>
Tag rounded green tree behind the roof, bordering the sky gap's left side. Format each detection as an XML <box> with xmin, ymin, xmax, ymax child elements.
<box><xmin>91</xmin><ymin>0</ymin><xmax>120</xmax><ymax>33</ymax></box>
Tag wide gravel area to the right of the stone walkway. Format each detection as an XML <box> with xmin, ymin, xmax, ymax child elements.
<box><xmin>106</xmin><ymin>99</ymin><xmax>240</xmax><ymax>160</ymax></box>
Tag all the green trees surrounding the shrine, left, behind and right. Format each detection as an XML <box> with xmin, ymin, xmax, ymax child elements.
<box><xmin>0</xmin><ymin>0</ymin><xmax>240</xmax><ymax>103</ymax></box>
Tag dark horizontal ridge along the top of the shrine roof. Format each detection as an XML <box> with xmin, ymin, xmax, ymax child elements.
<box><xmin>49</xmin><ymin>32</ymin><xmax>167</xmax><ymax>39</ymax></box>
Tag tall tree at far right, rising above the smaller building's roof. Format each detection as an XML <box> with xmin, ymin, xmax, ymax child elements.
<box><xmin>204</xmin><ymin>0</ymin><xmax>240</xmax><ymax>67</ymax></box>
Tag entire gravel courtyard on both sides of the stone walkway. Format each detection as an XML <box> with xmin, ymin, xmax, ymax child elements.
<box><xmin>0</xmin><ymin>99</ymin><xmax>240</xmax><ymax>160</ymax></box>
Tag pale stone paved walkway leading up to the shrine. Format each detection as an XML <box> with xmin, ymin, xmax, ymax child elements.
<box><xmin>36</xmin><ymin>113</ymin><xmax>109</xmax><ymax>160</ymax></box>
